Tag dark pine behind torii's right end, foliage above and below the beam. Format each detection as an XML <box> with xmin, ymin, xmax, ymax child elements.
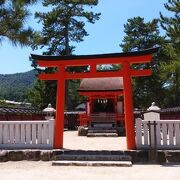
<box><xmin>120</xmin><ymin>17</ymin><xmax>165</xmax><ymax>108</ymax></box>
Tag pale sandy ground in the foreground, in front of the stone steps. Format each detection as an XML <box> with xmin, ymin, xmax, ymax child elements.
<box><xmin>0</xmin><ymin>161</ymin><xmax>180</xmax><ymax>180</ymax></box>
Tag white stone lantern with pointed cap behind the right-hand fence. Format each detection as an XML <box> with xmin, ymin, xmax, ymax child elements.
<box><xmin>144</xmin><ymin>102</ymin><xmax>161</xmax><ymax>121</ymax></box>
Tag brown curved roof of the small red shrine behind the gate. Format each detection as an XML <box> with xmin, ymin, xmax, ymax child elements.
<box><xmin>78</xmin><ymin>77</ymin><xmax>123</xmax><ymax>92</ymax></box>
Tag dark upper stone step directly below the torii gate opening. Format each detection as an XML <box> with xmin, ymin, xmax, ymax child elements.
<box><xmin>55</xmin><ymin>154</ymin><xmax>132</xmax><ymax>161</ymax></box>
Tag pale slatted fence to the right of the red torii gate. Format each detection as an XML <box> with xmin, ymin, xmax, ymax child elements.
<box><xmin>136</xmin><ymin>118</ymin><xmax>180</xmax><ymax>149</ymax></box>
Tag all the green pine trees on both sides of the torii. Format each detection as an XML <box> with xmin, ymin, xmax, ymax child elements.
<box><xmin>0</xmin><ymin>0</ymin><xmax>180</xmax><ymax>109</ymax></box>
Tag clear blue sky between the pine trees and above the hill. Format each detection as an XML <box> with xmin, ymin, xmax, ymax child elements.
<box><xmin>0</xmin><ymin>0</ymin><xmax>167</xmax><ymax>74</ymax></box>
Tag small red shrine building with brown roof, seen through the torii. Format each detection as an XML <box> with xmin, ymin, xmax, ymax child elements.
<box><xmin>78</xmin><ymin>77</ymin><xmax>124</xmax><ymax>126</ymax></box>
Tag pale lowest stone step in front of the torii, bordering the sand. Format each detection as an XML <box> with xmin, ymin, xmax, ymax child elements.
<box><xmin>52</xmin><ymin>161</ymin><xmax>132</xmax><ymax>167</ymax></box>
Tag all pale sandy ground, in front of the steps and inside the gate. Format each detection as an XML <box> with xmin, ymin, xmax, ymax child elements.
<box><xmin>0</xmin><ymin>131</ymin><xmax>180</xmax><ymax>180</ymax></box>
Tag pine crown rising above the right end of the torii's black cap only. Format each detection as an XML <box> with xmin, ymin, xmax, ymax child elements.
<box><xmin>120</xmin><ymin>17</ymin><xmax>163</xmax><ymax>52</ymax></box>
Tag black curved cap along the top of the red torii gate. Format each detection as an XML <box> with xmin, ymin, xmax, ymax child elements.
<box><xmin>31</xmin><ymin>47</ymin><xmax>159</xmax><ymax>61</ymax></box>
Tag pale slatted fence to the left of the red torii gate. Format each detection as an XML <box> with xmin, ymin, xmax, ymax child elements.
<box><xmin>0</xmin><ymin>119</ymin><xmax>54</xmax><ymax>149</ymax></box>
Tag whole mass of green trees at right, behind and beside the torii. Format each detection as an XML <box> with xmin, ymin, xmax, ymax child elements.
<box><xmin>121</xmin><ymin>0</ymin><xmax>180</xmax><ymax>108</ymax></box>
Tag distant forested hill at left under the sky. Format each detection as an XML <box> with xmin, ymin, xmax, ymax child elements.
<box><xmin>0</xmin><ymin>70</ymin><xmax>35</xmax><ymax>101</ymax></box>
